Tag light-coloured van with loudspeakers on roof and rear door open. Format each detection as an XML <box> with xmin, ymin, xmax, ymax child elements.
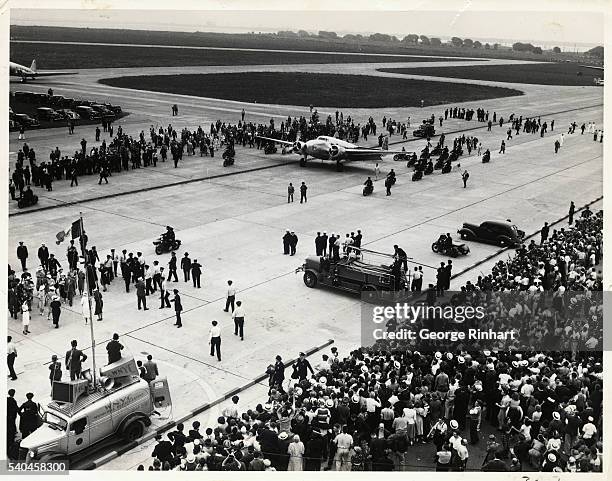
<box><xmin>20</xmin><ymin>358</ymin><xmax>171</xmax><ymax>462</ymax></box>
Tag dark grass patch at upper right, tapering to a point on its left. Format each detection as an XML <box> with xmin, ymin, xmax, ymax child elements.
<box><xmin>380</xmin><ymin>63</ymin><xmax>603</xmax><ymax>85</ymax></box>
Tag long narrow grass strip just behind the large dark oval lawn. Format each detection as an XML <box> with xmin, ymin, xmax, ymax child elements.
<box><xmin>11</xmin><ymin>42</ymin><xmax>478</xmax><ymax>70</ymax></box>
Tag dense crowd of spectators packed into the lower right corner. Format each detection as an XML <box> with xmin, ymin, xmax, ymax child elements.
<box><xmin>139</xmin><ymin>208</ymin><xmax>603</xmax><ymax>472</ymax></box>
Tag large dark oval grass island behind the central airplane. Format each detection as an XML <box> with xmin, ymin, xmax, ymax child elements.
<box><xmin>100</xmin><ymin>72</ymin><xmax>523</xmax><ymax>108</ymax></box>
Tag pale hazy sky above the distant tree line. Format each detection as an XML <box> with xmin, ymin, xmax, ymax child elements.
<box><xmin>11</xmin><ymin>0</ymin><xmax>604</xmax><ymax>46</ymax></box>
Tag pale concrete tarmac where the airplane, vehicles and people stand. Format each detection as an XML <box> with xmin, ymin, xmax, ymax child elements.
<box><xmin>8</xmin><ymin>56</ymin><xmax>603</xmax><ymax>469</ymax></box>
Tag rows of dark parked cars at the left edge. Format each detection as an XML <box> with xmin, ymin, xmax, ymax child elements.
<box><xmin>9</xmin><ymin>91</ymin><xmax>121</xmax><ymax>128</ymax></box>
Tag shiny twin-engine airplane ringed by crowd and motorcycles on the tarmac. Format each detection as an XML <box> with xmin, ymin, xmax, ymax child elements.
<box><xmin>259</xmin><ymin>135</ymin><xmax>412</xmax><ymax>170</ymax></box>
